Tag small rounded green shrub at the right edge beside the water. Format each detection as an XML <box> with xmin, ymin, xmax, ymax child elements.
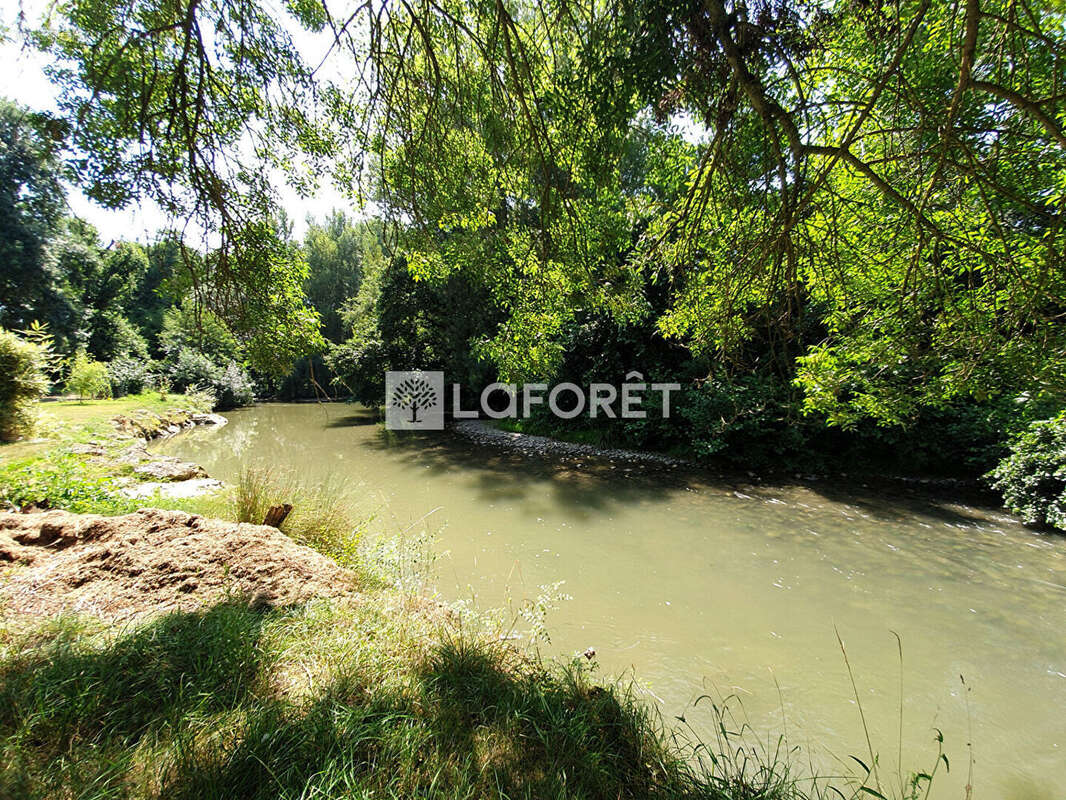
<box><xmin>990</xmin><ymin>412</ymin><xmax>1066</xmax><ymax>530</ymax></box>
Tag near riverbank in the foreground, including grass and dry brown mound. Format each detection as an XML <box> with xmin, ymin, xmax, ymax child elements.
<box><xmin>0</xmin><ymin>398</ymin><xmax>903</xmax><ymax>800</ymax></box>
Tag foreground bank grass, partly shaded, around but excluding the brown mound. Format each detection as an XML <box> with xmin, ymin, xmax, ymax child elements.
<box><xmin>0</xmin><ymin>400</ymin><xmax>924</xmax><ymax>800</ymax></box>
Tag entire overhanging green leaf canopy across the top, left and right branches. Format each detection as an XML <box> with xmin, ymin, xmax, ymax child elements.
<box><xmin>16</xmin><ymin>0</ymin><xmax>1066</xmax><ymax>426</ymax></box>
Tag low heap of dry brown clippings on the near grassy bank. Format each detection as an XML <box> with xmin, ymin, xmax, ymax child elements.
<box><xmin>0</xmin><ymin>509</ymin><xmax>353</xmax><ymax>619</ymax></box>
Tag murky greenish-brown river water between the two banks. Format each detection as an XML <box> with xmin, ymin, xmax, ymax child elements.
<box><xmin>156</xmin><ymin>404</ymin><xmax>1066</xmax><ymax>800</ymax></box>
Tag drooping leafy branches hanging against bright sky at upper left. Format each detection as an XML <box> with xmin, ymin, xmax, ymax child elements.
<box><xmin>31</xmin><ymin>0</ymin><xmax>328</xmax><ymax>372</ymax></box>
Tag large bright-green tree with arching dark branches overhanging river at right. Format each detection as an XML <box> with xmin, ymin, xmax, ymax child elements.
<box><xmin>351</xmin><ymin>0</ymin><xmax>1066</xmax><ymax>426</ymax></box>
